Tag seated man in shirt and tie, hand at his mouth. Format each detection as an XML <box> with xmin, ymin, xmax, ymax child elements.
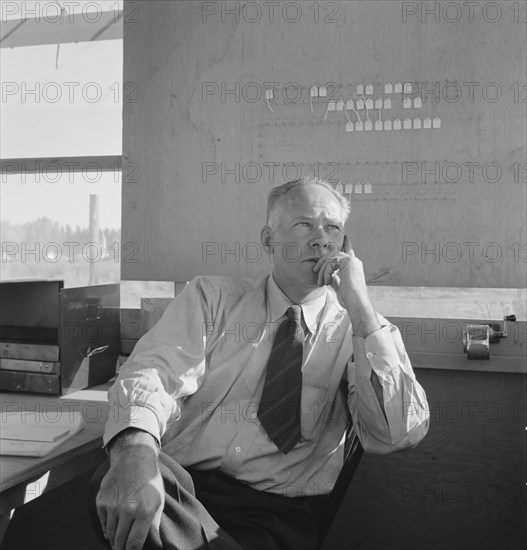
<box><xmin>94</xmin><ymin>178</ymin><xmax>428</xmax><ymax>550</ymax></box>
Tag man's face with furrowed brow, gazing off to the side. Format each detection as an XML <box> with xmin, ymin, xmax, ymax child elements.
<box><xmin>264</xmin><ymin>185</ymin><xmax>344</xmax><ymax>290</ymax></box>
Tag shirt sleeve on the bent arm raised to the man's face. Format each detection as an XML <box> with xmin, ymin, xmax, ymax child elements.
<box><xmin>348</xmin><ymin>321</ymin><xmax>429</xmax><ymax>454</ymax></box>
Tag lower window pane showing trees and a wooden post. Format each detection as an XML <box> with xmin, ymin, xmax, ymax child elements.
<box><xmin>0</xmin><ymin>172</ymin><xmax>121</xmax><ymax>287</ymax></box>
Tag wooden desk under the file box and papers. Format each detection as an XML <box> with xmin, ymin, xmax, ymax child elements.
<box><xmin>0</xmin><ymin>383</ymin><xmax>111</xmax><ymax>542</ymax></box>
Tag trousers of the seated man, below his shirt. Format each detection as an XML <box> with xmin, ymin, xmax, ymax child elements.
<box><xmin>89</xmin><ymin>452</ymin><xmax>327</xmax><ymax>550</ymax></box>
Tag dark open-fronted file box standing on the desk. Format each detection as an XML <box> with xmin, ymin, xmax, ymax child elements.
<box><xmin>0</xmin><ymin>281</ymin><xmax>120</xmax><ymax>395</ymax></box>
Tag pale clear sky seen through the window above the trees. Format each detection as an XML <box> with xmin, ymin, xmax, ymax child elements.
<box><xmin>0</xmin><ymin>0</ymin><xmax>123</xmax><ymax>228</ymax></box>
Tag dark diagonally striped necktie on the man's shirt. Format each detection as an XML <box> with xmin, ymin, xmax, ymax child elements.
<box><xmin>258</xmin><ymin>305</ymin><xmax>304</xmax><ymax>454</ymax></box>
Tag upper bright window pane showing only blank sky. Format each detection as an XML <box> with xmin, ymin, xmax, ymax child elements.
<box><xmin>0</xmin><ymin>9</ymin><xmax>122</xmax><ymax>158</ymax></box>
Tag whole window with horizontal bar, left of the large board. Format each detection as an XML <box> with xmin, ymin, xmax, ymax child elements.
<box><xmin>0</xmin><ymin>1</ymin><xmax>123</xmax><ymax>286</ymax></box>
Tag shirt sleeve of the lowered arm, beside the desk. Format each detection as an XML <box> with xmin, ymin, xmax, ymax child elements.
<box><xmin>103</xmin><ymin>277</ymin><xmax>212</xmax><ymax>445</ymax></box>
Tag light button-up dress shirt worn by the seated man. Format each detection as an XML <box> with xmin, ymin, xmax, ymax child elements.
<box><xmin>104</xmin><ymin>275</ymin><xmax>428</xmax><ymax>497</ymax></box>
